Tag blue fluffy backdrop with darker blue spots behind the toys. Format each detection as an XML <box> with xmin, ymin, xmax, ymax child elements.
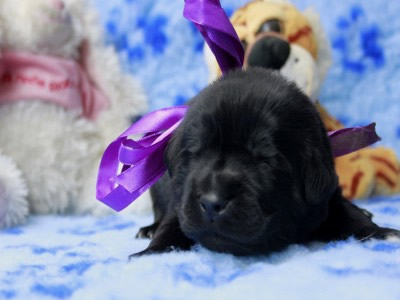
<box><xmin>94</xmin><ymin>0</ymin><xmax>400</xmax><ymax>155</ymax></box>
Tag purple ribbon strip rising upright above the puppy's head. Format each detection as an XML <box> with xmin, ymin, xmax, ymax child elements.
<box><xmin>183</xmin><ymin>0</ymin><xmax>244</xmax><ymax>73</ymax></box>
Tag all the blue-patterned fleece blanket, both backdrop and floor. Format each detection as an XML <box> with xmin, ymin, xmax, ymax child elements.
<box><xmin>0</xmin><ymin>0</ymin><xmax>400</xmax><ymax>300</ymax></box>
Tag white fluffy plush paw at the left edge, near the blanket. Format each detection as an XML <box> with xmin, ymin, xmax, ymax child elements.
<box><xmin>0</xmin><ymin>153</ymin><xmax>29</xmax><ymax>228</ymax></box>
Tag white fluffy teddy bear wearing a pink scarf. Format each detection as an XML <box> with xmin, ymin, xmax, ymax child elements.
<box><xmin>0</xmin><ymin>0</ymin><xmax>146</xmax><ymax>228</ymax></box>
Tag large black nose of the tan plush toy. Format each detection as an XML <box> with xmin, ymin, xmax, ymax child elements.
<box><xmin>247</xmin><ymin>36</ymin><xmax>290</xmax><ymax>70</ymax></box>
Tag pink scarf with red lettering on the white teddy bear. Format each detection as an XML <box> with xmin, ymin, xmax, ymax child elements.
<box><xmin>0</xmin><ymin>51</ymin><xmax>108</xmax><ymax>120</ymax></box>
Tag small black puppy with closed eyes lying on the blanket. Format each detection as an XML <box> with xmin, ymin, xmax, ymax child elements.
<box><xmin>132</xmin><ymin>68</ymin><xmax>400</xmax><ymax>255</ymax></box>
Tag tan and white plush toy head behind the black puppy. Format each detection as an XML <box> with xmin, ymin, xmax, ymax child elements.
<box><xmin>205</xmin><ymin>0</ymin><xmax>331</xmax><ymax>99</ymax></box>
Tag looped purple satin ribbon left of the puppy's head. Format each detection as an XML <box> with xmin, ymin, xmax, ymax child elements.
<box><xmin>96</xmin><ymin>106</ymin><xmax>188</xmax><ymax>211</ymax></box>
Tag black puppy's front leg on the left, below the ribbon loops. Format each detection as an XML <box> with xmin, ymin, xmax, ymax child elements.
<box><xmin>129</xmin><ymin>215</ymin><xmax>194</xmax><ymax>258</ymax></box>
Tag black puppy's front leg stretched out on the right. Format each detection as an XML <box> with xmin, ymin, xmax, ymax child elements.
<box><xmin>312</xmin><ymin>192</ymin><xmax>400</xmax><ymax>242</ymax></box>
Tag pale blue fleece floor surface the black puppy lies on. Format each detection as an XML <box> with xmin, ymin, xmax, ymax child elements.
<box><xmin>0</xmin><ymin>197</ymin><xmax>400</xmax><ymax>300</ymax></box>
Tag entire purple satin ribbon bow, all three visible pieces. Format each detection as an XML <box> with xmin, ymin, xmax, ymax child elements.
<box><xmin>96</xmin><ymin>0</ymin><xmax>380</xmax><ymax>211</ymax></box>
